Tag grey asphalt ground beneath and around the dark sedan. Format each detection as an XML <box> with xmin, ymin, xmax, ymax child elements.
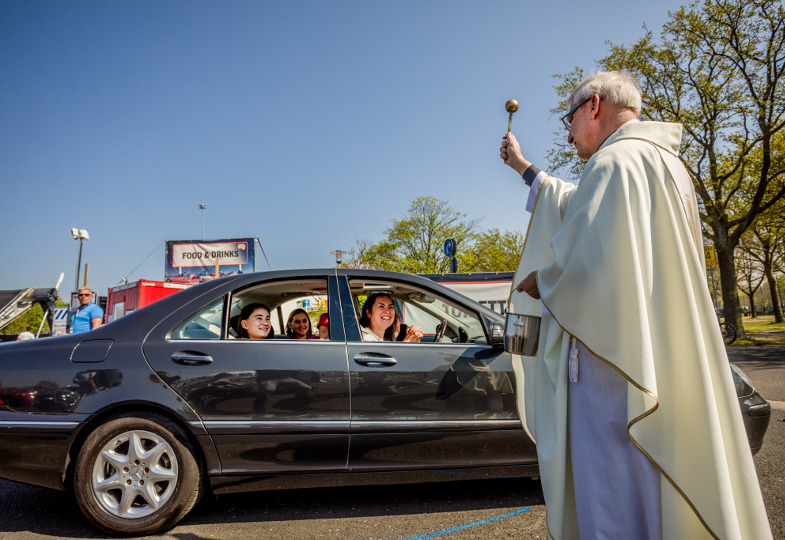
<box><xmin>0</xmin><ymin>347</ymin><xmax>785</xmax><ymax>540</ymax></box>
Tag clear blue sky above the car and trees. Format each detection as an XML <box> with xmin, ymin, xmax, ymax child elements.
<box><xmin>0</xmin><ymin>0</ymin><xmax>680</xmax><ymax>297</ymax></box>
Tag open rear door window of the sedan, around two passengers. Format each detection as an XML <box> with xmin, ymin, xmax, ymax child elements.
<box><xmin>228</xmin><ymin>279</ymin><xmax>329</xmax><ymax>339</ymax></box>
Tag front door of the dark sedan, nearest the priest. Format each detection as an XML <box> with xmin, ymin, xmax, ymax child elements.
<box><xmin>339</xmin><ymin>274</ymin><xmax>536</xmax><ymax>470</ymax></box>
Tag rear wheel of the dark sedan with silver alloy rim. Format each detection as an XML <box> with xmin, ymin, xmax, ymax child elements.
<box><xmin>73</xmin><ymin>413</ymin><xmax>204</xmax><ymax>536</ymax></box>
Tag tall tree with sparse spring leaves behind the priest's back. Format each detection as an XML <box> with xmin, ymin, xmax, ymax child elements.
<box><xmin>551</xmin><ymin>0</ymin><xmax>785</xmax><ymax>337</ymax></box>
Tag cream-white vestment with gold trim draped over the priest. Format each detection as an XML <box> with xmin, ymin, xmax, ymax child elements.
<box><xmin>509</xmin><ymin>122</ymin><xmax>771</xmax><ymax>540</ymax></box>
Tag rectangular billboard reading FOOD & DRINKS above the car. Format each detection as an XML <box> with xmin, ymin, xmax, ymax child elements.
<box><xmin>164</xmin><ymin>238</ymin><xmax>256</xmax><ymax>283</ymax></box>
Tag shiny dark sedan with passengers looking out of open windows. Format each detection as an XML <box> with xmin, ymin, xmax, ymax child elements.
<box><xmin>0</xmin><ymin>269</ymin><xmax>768</xmax><ymax>536</ymax></box>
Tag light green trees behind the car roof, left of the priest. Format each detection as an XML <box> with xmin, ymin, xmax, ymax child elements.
<box><xmin>345</xmin><ymin>196</ymin><xmax>523</xmax><ymax>274</ymax></box>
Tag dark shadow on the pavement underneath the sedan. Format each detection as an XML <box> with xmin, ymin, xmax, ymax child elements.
<box><xmin>0</xmin><ymin>478</ymin><xmax>544</xmax><ymax>540</ymax></box>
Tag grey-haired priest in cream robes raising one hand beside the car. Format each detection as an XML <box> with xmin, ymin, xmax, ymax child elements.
<box><xmin>501</xmin><ymin>72</ymin><xmax>771</xmax><ymax>540</ymax></box>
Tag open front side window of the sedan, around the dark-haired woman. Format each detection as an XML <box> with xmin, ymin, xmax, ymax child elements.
<box><xmin>349</xmin><ymin>278</ymin><xmax>487</xmax><ymax>343</ymax></box>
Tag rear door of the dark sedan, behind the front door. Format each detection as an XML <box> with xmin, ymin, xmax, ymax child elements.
<box><xmin>143</xmin><ymin>276</ymin><xmax>349</xmax><ymax>475</ymax></box>
